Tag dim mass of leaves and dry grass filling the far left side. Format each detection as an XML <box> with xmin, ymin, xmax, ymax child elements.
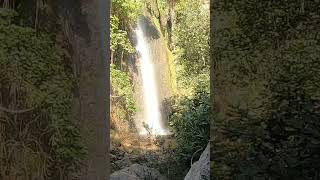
<box><xmin>0</xmin><ymin>8</ymin><xmax>85</xmax><ymax>179</ymax></box>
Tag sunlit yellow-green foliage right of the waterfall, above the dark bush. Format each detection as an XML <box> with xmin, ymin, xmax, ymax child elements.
<box><xmin>173</xmin><ymin>0</ymin><xmax>210</xmax><ymax>97</ymax></box>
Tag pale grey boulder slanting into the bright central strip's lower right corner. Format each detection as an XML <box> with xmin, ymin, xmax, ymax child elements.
<box><xmin>184</xmin><ymin>144</ymin><xmax>210</xmax><ymax>180</ymax></box>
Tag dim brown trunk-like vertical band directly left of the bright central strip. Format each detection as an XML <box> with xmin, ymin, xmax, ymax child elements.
<box><xmin>79</xmin><ymin>0</ymin><xmax>109</xmax><ymax>180</ymax></box>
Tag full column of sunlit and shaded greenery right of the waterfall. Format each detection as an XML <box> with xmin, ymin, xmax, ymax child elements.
<box><xmin>169</xmin><ymin>0</ymin><xmax>211</xmax><ymax>167</ymax></box>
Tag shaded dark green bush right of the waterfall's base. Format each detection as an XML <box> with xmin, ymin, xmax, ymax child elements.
<box><xmin>169</xmin><ymin>91</ymin><xmax>211</xmax><ymax>163</ymax></box>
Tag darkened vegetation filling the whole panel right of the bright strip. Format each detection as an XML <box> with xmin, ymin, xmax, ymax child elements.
<box><xmin>212</xmin><ymin>0</ymin><xmax>320</xmax><ymax>179</ymax></box>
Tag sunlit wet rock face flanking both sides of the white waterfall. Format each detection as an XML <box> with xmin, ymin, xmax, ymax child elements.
<box><xmin>128</xmin><ymin>16</ymin><xmax>174</xmax><ymax>132</ymax></box>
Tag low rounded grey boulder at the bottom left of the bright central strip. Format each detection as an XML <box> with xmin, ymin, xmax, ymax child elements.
<box><xmin>110</xmin><ymin>164</ymin><xmax>166</xmax><ymax>180</ymax></box>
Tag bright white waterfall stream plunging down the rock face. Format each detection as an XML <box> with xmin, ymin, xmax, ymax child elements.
<box><xmin>135</xmin><ymin>21</ymin><xmax>170</xmax><ymax>135</ymax></box>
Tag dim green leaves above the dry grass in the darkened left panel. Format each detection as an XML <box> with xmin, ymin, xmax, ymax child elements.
<box><xmin>0</xmin><ymin>10</ymin><xmax>85</xmax><ymax>177</ymax></box>
